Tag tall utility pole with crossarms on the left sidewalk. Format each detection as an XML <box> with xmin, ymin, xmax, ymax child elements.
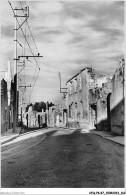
<box><xmin>8</xmin><ymin>1</ymin><xmax>43</xmax><ymax>132</ymax></box>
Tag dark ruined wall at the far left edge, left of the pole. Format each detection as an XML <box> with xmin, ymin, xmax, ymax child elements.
<box><xmin>1</xmin><ymin>79</ymin><xmax>8</xmax><ymax>133</ymax></box>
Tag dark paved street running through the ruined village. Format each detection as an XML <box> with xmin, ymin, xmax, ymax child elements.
<box><xmin>1</xmin><ymin>129</ymin><xmax>124</xmax><ymax>188</ymax></box>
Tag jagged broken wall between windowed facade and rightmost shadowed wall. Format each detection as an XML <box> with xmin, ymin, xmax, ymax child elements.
<box><xmin>89</xmin><ymin>74</ymin><xmax>111</xmax><ymax>131</ymax></box>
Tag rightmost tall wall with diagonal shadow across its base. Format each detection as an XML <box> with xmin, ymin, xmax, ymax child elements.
<box><xmin>110</xmin><ymin>59</ymin><xmax>125</xmax><ymax>135</ymax></box>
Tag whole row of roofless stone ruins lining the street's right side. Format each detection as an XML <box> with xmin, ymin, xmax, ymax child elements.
<box><xmin>59</xmin><ymin>59</ymin><xmax>125</xmax><ymax>135</ymax></box>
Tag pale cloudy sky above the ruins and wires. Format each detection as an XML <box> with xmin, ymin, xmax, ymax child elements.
<box><xmin>1</xmin><ymin>1</ymin><xmax>124</xmax><ymax>104</ymax></box>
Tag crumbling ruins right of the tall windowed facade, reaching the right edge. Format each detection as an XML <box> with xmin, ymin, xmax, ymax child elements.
<box><xmin>89</xmin><ymin>59</ymin><xmax>125</xmax><ymax>135</ymax></box>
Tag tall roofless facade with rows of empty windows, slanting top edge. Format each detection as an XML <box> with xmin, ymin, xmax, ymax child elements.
<box><xmin>66</xmin><ymin>67</ymin><xmax>93</xmax><ymax>127</ymax></box>
